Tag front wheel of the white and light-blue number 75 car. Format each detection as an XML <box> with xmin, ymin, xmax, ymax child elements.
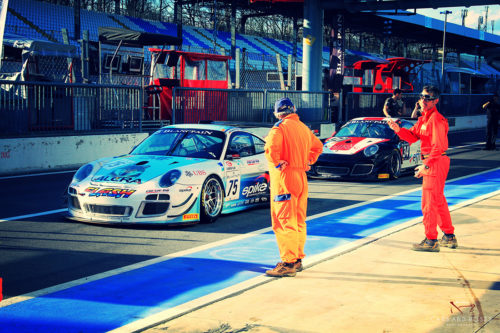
<box><xmin>200</xmin><ymin>176</ymin><xmax>224</xmax><ymax>223</ymax></box>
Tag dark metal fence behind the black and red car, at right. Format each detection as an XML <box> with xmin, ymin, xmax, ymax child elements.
<box><xmin>341</xmin><ymin>93</ymin><xmax>491</xmax><ymax>121</ymax></box>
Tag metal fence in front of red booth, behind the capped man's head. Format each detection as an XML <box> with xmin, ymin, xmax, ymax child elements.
<box><xmin>173</xmin><ymin>88</ymin><xmax>331</xmax><ymax>125</ymax></box>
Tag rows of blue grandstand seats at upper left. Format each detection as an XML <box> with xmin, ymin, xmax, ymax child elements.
<box><xmin>6</xmin><ymin>0</ymin><xmax>328</xmax><ymax>69</ymax></box>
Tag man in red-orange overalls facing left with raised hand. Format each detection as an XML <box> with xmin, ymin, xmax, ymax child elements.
<box><xmin>388</xmin><ymin>86</ymin><xmax>458</xmax><ymax>252</ymax></box>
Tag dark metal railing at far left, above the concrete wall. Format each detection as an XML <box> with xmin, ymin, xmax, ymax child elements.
<box><xmin>0</xmin><ymin>80</ymin><xmax>143</xmax><ymax>137</ymax></box>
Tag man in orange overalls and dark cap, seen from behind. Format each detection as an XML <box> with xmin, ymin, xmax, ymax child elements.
<box><xmin>265</xmin><ymin>98</ymin><xmax>323</xmax><ymax>277</ymax></box>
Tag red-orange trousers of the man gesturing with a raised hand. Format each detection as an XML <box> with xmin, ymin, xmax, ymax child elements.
<box><xmin>422</xmin><ymin>156</ymin><xmax>455</xmax><ymax>239</ymax></box>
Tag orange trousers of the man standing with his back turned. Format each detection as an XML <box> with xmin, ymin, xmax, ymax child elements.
<box><xmin>269</xmin><ymin>167</ymin><xmax>308</xmax><ymax>263</ymax></box>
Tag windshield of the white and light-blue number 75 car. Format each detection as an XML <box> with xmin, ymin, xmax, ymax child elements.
<box><xmin>130</xmin><ymin>128</ymin><xmax>225</xmax><ymax>159</ymax></box>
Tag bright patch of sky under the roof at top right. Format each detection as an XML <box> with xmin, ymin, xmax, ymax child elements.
<box><xmin>417</xmin><ymin>5</ymin><xmax>500</xmax><ymax>35</ymax></box>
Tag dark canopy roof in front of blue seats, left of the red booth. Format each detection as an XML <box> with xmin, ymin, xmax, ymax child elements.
<box><xmin>99</xmin><ymin>27</ymin><xmax>182</xmax><ymax>47</ymax></box>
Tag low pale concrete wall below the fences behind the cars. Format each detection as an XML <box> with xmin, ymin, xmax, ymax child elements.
<box><xmin>0</xmin><ymin>115</ymin><xmax>486</xmax><ymax>176</ymax></box>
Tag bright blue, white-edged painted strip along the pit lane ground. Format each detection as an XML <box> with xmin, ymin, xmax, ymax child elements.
<box><xmin>0</xmin><ymin>168</ymin><xmax>500</xmax><ymax>333</ymax></box>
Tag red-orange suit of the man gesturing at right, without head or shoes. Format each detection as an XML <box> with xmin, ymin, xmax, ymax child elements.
<box><xmin>397</xmin><ymin>107</ymin><xmax>454</xmax><ymax>239</ymax></box>
